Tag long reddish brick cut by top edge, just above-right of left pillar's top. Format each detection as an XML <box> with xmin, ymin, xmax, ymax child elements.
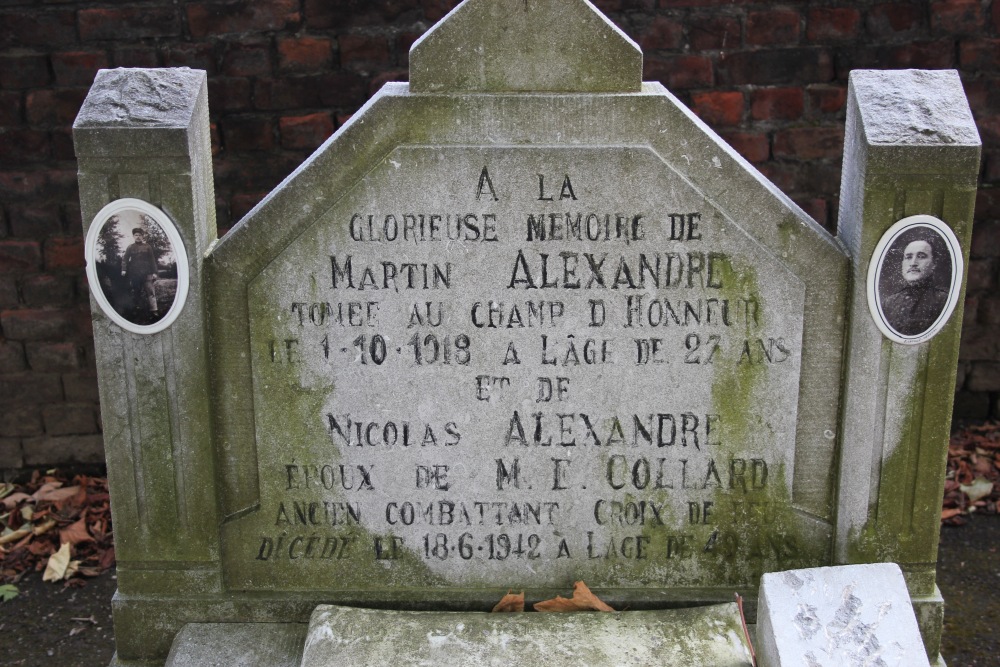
<box><xmin>187</xmin><ymin>0</ymin><xmax>302</xmax><ymax>37</ymax></box>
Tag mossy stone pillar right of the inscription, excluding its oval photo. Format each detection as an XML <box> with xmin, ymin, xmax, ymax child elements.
<box><xmin>836</xmin><ymin>70</ymin><xmax>981</xmax><ymax>660</ymax></box>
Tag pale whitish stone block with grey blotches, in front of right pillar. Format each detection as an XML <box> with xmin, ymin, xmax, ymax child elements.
<box><xmin>756</xmin><ymin>563</ymin><xmax>929</xmax><ymax>667</ymax></box>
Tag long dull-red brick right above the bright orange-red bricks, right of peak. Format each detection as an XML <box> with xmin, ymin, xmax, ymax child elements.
<box><xmin>716</xmin><ymin>48</ymin><xmax>833</xmax><ymax>86</ymax></box>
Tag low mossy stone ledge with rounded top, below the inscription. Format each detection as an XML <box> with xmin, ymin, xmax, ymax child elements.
<box><xmin>302</xmin><ymin>603</ymin><xmax>752</xmax><ymax>667</ymax></box>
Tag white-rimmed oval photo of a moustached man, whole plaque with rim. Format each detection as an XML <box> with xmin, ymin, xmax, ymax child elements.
<box><xmin>867</xmin><ymin>215</ymin><xmax>964</xmax><ymax>345</ymax></box>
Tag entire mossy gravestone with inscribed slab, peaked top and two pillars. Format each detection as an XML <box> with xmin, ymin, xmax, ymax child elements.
<box><xmin>74</xmin><ymin>0</ymin><xmax>979</xmax><ymax>665</ymax></box>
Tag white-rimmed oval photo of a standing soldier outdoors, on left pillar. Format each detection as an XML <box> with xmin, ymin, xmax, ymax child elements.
<box><xmin>84</xmin><ymin>198</ymin><xmax>190</xmax><ymax>334</ymax></box>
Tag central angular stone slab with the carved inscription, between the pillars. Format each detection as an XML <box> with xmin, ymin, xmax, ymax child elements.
<box><xmin>211</xmin><ymin>96</ymin><xmax>844</xmax><ymax>608</ymax></box>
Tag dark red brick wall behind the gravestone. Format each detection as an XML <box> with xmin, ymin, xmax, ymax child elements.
<box><xmin>0</xmin><ymin>0</ymin><xmax>1000</xmax><ymax>469</ymax></box>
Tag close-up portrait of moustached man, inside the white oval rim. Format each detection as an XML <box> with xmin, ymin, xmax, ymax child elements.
<box><xmin>880</xmin><ymin>235</ymin><xmax>952</xmax><ymax>336</ymax></box>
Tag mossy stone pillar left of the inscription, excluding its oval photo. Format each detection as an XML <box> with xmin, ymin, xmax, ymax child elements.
<box><xmin>73</xmin><ymin>68</ymin><xmax>220</xmax><ymax>653</ymax></box>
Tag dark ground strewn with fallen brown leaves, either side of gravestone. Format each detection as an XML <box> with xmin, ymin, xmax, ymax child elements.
<box><xmin>0</xmin><ymin>516</ymin><xmax>1000</xmax><ymax>667</ymax></box>
